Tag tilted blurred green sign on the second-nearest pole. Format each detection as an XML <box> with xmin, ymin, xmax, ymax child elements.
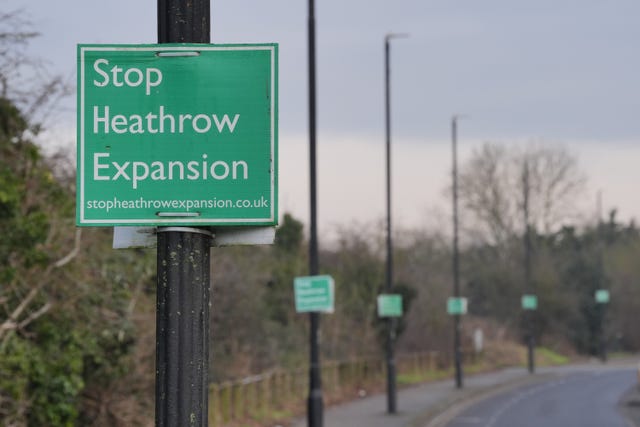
<box><xmin>293</xmin><ymin>275</ymin><xmax>335</xmax><ymax>313</ymax></box>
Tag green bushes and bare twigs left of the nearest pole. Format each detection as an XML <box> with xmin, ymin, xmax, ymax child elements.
<box><xmin>0</xmin><ymin>14</ymin><xmax>149</xmax><ymax>427</ymax></box>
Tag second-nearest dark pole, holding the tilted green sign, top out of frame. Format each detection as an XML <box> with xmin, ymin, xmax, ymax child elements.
<box><xmin>307</xmin><ymin>0</ymin><xmax>324</xmax><ymax>427</ymax></box>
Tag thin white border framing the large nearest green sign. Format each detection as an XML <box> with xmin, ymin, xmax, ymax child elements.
<box><xmin>79</xmin><ymin>45</ymin><xmax>277</xmax><ymax>225</ymax></box>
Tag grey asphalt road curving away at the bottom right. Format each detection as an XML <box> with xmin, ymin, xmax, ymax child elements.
<box><xmin>446</xmin><ymin>367</ymin><xmax>637</xmax><ymax>427</ymax></box>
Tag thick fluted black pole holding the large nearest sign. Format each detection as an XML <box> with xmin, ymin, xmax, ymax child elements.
<box><xmin>156</xmin><ymin>0</ymin><xmax>212</xmax><ymax>427</ymax></box>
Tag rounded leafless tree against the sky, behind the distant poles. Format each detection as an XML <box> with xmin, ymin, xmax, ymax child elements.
<box><xmin>459</xmin><ymin>143</ymin><xmax>586</xmax><ymax>244</ymax></box>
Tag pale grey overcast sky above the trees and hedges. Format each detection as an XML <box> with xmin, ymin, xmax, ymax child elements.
<box><xmin>5</xmin><ymin>0</ymin><xmax>640</xmax><ymax>236</ymax></box>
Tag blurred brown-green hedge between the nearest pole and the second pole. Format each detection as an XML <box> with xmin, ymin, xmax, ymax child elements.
<box><xmin>210</xmin><ymin>214</ymin><xmax>307</xmax><ymax>381</ymax></box>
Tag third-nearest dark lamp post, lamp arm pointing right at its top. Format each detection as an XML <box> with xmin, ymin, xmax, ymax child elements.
<box><xmin>384</xmin><ymin>33</ymin><xmax>408</xmax><ymax>414</ymax></box>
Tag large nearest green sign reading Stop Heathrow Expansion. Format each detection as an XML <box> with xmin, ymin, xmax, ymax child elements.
<box><xmin>76</xmin><ymin>44</ymin><xmax>278</xmax><ymax>226</ymax></box>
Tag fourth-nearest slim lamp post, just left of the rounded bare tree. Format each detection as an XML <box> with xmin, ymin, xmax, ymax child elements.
<box><xmin>451</xmin><ymin>116</ymin><xmax>463</xmax><ymax>388</ymax></box>
